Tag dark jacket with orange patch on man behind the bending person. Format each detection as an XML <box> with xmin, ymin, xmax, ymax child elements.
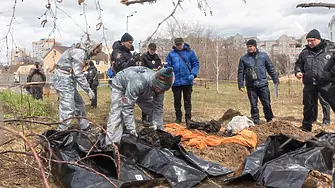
<box><xmin>111</xmin><ymin>41</ymin><xmax>136</xmax><ymax>74</ymax></box>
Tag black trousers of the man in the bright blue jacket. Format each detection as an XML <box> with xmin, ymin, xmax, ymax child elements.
<box><xmin>172</xmin><ymin>85</ymin><xmax>193</xmax><ymax>120</ymax></box>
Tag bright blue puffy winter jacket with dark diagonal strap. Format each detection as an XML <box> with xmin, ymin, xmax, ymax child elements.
<box><xmin>166</xmin><ymin>43</ymin><xmax>199</xmax><ymax>86</ymax></box>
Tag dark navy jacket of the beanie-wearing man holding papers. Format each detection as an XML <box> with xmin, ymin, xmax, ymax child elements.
<box><xmin>237</xmin><ymin>50</ymin><xmax>279</xmax><ymax>89</ymax></box>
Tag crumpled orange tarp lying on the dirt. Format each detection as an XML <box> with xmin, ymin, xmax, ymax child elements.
<box><xmin>165</xmin><ymin>123</ymin><xmax>257</xmax><ymax>149</ymax></box>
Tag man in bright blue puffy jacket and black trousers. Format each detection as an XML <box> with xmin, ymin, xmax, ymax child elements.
<box><xmin>166</xmin><ymin>38</ymin><xmax>199</xmax><ymax>124</ymax></box>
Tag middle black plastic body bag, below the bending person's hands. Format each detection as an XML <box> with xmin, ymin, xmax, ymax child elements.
<box><xmin>120</xmin><ymin>131</ymin><xmax>233</xmax><ymax>188</ymax></box>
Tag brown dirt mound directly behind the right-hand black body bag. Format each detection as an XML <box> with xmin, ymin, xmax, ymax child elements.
<box><xmin>250</xmin><ymin>121</ymin><xmax>315</xmax><ymax>145</ymax></box>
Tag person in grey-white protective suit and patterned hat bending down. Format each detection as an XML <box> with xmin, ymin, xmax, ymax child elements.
<box><xmin>106</xmin><ymin>66</ymin><xmax>174</xmax><ymax>145</ymax></box>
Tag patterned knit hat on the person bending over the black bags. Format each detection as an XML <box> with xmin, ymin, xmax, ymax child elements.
<box><xmin>152</xmin><ymin>67</ymin><xmax>173</xmax><ymax>91</ymax></box>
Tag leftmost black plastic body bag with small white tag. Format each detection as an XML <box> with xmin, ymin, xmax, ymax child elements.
<box><xmin>44</xmin><ymin>131</ymin><xmax>156</xmax><ymax>188</ymax></box>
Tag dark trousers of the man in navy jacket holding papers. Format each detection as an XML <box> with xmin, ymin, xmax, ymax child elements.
<box><xmin>247</xmin><ymin>85</ymin><xmax>273</xmax><ymax>121</ymax></box>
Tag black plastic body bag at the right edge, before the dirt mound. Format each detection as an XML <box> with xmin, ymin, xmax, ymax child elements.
<box><xmin>230</xmin><ymin>133</ymin><xmax>335</xmax><ymax>188</ymax></box>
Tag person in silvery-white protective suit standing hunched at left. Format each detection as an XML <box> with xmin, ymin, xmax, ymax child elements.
<box><xmin>52</xmin><ymin>40</ymin><xmax>102</xmax><ymax>130</ymax></box>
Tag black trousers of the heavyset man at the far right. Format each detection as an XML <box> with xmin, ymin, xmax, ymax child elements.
<box><xmin>302</xmin><ymin>83</ymin><xmax>335</xmax><ymax>128</ymax></box>
